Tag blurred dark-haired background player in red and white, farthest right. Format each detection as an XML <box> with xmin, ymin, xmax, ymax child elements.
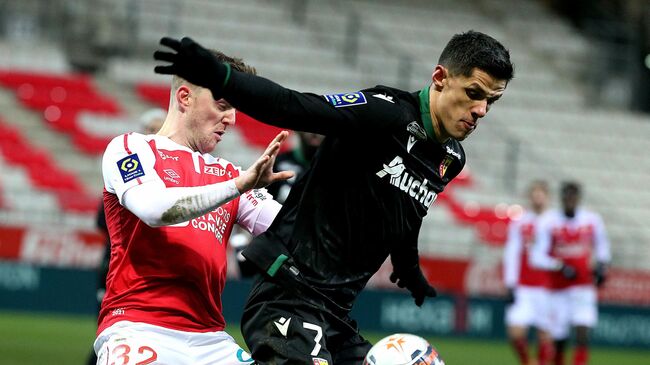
<box><xmin>531</xmin><ymin>182</ymin><xmax>611</xmax><ymax>365</ymax></box>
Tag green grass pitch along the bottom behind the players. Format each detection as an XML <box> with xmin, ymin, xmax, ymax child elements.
<box><xmin>0</xmin><ymin>312</ymin><xmax>650</xmax><ymax>365</ymax></box>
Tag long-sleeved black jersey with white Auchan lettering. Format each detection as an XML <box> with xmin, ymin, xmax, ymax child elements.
<box><xmin>224</xmin><ymin>72</ymin><xmax>465</xmax><ymax>308</ymax></box>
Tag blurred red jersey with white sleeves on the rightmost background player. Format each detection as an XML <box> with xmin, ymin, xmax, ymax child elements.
<box><xmin>533</xmin><ymin>209</ymin><xmax>611</xmax><ymax>289</ymax></box>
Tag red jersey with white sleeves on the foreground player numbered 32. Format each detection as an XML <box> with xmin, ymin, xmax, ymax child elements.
<box><xmin>97</xmin><ymin>133</ymin><xmax>280</xmax><ymax>334</ymax></box>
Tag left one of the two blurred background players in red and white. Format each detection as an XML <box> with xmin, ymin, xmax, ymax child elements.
<box><xmin>503</xmin><ymin>180</ymin><xmax>553</xmax><ymax>365</ymax></box>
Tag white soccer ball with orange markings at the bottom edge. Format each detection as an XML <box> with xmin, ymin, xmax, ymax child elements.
<box><xmin>363</xmin><ymin>333</ymin><xmax>445</xmax><ymax>365</ymax></box>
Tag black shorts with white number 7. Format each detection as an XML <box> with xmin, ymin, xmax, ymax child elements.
<box><xmin>241</xmin><ymin>277</ymin><xmax>372</xmax><ymax>365</ymax></box>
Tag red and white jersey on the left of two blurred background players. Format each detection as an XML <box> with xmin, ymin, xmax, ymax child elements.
<box><xmin>503</xmin><ymin>211</ymin><xmax>550</xmax><ymax>288</ymax></box>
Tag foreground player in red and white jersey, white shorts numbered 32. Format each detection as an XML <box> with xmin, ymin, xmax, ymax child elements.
<box><xmin>94</xmin><ymin>52</ymin><xmax>293</xmax><ymax>365</ymax></box>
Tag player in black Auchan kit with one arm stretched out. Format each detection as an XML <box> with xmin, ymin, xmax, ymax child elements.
<box><xmin>154</xmin><ymin>31</ymin><xmax>513</xmax><ymax>365</ymax></box>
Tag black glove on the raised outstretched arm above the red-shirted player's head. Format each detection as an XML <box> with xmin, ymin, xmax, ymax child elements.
<box><xmin>153</xmin><ymin>37</ymin><xmax>230</xmax><ymax>100</ymax></box>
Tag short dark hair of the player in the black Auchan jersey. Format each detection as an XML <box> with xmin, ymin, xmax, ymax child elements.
<box><xmin>438</xmin><ymin>30</ymin><xmax>514</xmax><ymax>81</ymax></box>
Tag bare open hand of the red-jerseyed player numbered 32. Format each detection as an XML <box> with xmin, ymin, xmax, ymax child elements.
<box><xmin>235</xmin><ymin>131</ymin><xmax>293</xmax><ymax>193</ymax></box>
